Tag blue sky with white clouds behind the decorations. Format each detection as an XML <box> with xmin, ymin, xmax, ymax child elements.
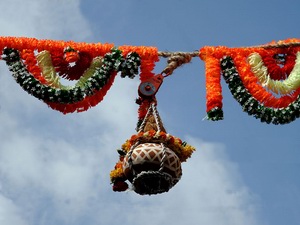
<box><xmin>0</xmin><ymin>0</ymin><xmax>300</xmax><ymax>225</ymax></box>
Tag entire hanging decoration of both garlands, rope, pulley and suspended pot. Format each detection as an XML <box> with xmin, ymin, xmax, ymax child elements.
<box><xmin>0</xmin><ymin>37</ymin><xmax>300</xmax><ymax>195</ymax></box>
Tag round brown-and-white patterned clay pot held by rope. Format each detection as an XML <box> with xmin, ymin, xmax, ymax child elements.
<box><xmin>123</xmin><ymin>143</ymin><xmax>182</xmax><ymax>195</ymax></box>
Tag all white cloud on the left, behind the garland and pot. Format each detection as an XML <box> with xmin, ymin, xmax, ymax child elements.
<box><xmin>0</xmin><ymin>0</ymin><xmax>257</xmax><ymax>225</ymax></box>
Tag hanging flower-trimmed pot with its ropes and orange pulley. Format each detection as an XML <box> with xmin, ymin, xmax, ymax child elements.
<box><xmin>110</xmin><ymin>70</ymin><xmax>195</xmax><ymax>195</ymax></box>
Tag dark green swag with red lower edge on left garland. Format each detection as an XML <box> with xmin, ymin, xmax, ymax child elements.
<box><xmin>3</xmin><ymin>48</ymin><xmax>138</xmax><ymax>113</ymax></box>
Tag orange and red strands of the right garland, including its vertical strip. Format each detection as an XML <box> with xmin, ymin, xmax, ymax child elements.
<box><xmin>199</xmin><ymin>39</ymin><xmax>300</xmax><ymax>123</ymax></box>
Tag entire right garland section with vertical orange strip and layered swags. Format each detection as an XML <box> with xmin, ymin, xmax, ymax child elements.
<box><xmin>200</xmin><ymin>39</ymin><xmax>300</xmax><ymax>124</ymax></box>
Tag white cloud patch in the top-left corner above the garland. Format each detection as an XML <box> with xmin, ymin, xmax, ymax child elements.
<box><xmin>0</xmin><ymin>0</ymin><xmax>91</xmax><ymax>41</ymax></box>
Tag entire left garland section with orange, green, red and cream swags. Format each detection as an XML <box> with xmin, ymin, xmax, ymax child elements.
<box><xmin>0</xmin><ymin>37</ymin><xmax>158</xmax><ymax>114</ymax></box>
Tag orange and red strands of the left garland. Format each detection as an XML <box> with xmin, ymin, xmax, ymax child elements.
<box><xmin>0</xmin><ymin>37</ymin><xmax>159</xmax><ymax>113</ymax></box>
